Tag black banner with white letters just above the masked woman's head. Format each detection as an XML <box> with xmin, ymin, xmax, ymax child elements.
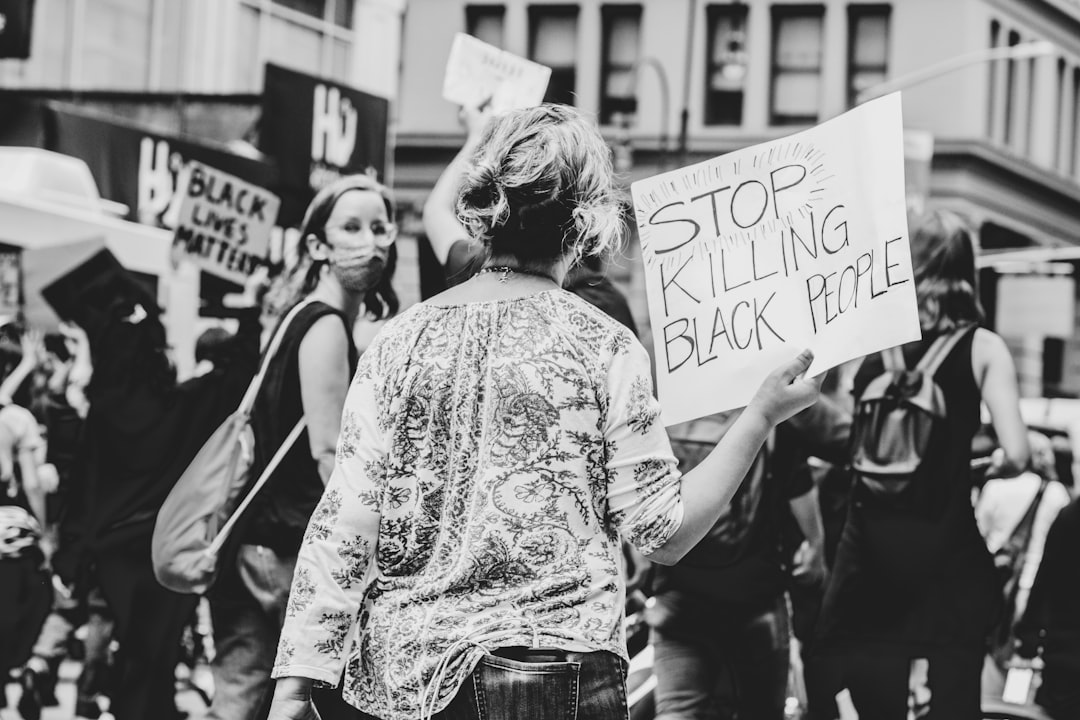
<box><xmin>259</xmin><ymin>65</ymin><xmax>390</xmax><ymax>227</ymax></box>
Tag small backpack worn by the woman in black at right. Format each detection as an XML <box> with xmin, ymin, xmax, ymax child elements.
<box><xmin>851</xmin><ymin>327</ymin><xmax>969</xmax><ymax>499</ymax></box>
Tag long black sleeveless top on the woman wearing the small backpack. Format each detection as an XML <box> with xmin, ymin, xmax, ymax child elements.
<box><xmin>819</xmin><ymin>329</ymin><xmax>1000</xmax><ymax>651</ymax></box>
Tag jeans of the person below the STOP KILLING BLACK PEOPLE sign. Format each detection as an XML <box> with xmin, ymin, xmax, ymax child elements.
<box><xmin>651</xmin><ymin>601</ymin><xmax>791</xmax><ymax>720</ymax></box>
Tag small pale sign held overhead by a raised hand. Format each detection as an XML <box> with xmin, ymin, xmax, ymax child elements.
<box><xmin>443</xmin><ymin>32</ymin><xmax>551</xmax><ymax>113</ymax></box>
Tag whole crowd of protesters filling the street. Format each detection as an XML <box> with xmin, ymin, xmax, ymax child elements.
<box><xmin>0</xmin><ymin>105</ymin><xmax>1080</xmax><ymax>720</ymax></box>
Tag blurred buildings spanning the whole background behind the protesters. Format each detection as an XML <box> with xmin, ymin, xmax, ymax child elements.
<box><xmin>0</xmin><ymin>0</ymin><xmax>1080</xmax><ymax>396</ymax></box>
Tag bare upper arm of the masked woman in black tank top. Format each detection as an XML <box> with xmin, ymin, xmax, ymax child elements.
<box><xmin>299</xmin><ymin>315</ymin><xmax>350</xmax><ymax>484</ymax></box>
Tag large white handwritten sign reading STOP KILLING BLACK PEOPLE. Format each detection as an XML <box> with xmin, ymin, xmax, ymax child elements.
<box><xmin>631</xmin><ymin>94</ymin><xmax>920</xmax><ymax>425</ymax></box>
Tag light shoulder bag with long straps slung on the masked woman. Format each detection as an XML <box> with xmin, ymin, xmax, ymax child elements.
<box><xmin>150</xmin><ymin>301</ymin><xmax>309</xmax><ymax>595</ymax></box>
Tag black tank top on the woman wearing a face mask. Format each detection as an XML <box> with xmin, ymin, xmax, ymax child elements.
<box><xmin>240</xmin><ymin>302</ymin><xmax>356</xmax><ymax>555</ymax></box>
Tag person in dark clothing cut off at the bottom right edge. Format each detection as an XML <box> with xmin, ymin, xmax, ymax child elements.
<box><xmin>1016</xmin><ymin>500</ymin><xmax>1080</xmax><ymax>720</ymax></box>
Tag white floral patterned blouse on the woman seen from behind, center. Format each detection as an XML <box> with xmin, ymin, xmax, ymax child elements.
<box><xmin>273</xmin><ymin>289</ymin><xmax>683</xmax><ymax>720</ymax></box>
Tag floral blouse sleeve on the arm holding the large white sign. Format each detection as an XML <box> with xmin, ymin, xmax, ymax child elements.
<box><xmin>604</xmin><ymin>331</ymin><xmax>684</xmax><ymax>555</ymax></box>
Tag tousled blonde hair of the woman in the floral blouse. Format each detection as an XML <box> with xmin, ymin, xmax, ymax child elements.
<box><xmin>457</xmin><ymin>105</ymin><xmax>625</xmax><ymax>261</ymax></box>
